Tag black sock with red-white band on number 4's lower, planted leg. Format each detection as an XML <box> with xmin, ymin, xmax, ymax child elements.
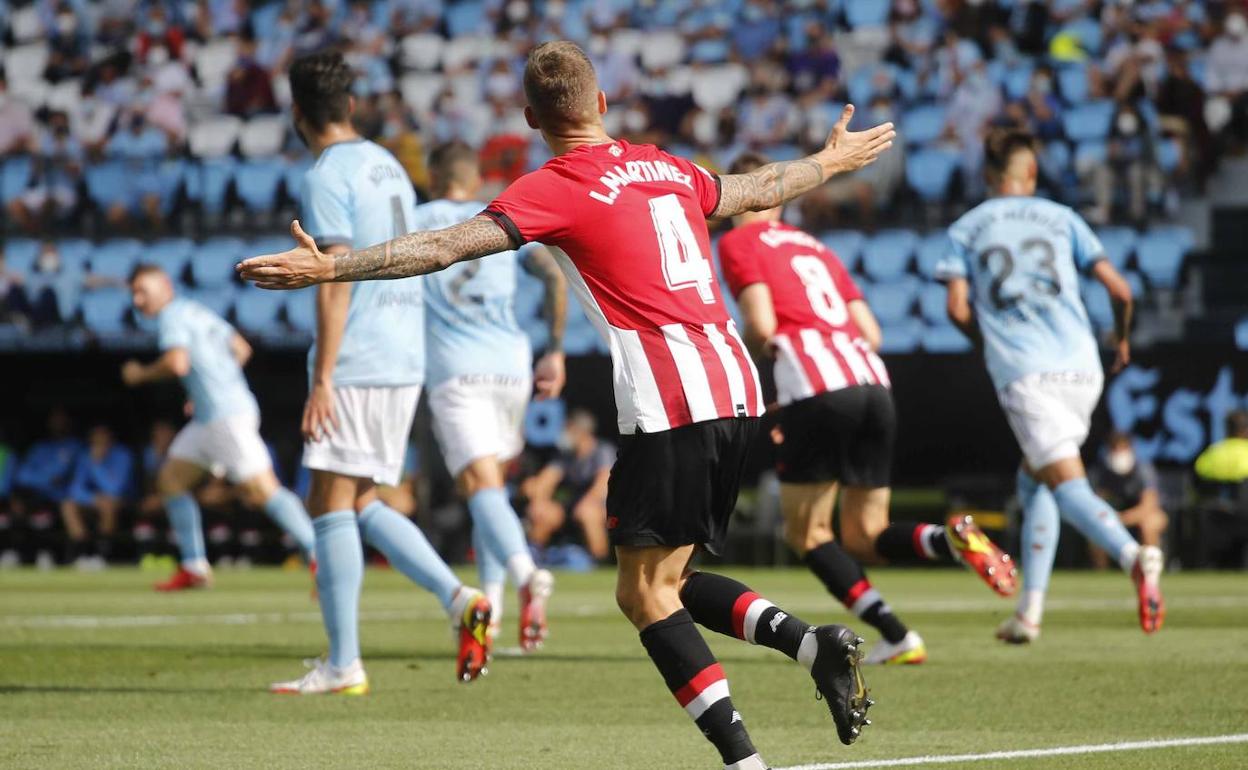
<box><xmin>641</xmin><ymin>609</ymin><xmax>758</xmax><ymax>765</ymax></box>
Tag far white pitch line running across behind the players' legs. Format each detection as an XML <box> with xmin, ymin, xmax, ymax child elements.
<box><xmin>0</xmin><ymin>595</ymin><xmax>1248</xmax><ymax>628</ymax></box>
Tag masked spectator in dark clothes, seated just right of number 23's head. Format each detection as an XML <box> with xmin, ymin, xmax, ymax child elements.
<box><xmin>1087</xmin><ymin>104</ymin><xmax>1161</xmax><ymax>226</ymax></box>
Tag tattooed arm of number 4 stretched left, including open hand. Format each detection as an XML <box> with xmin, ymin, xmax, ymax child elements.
<box><xmin>237</xmin><ymin>216</ymin><xmax>515</xmax><ymax>288</ymax></box>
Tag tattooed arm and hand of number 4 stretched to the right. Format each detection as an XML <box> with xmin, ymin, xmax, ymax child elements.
<box><xmin>714</xmin><ymin>105</ymin><xmax>896</xmax><ymax>217</ymax></box>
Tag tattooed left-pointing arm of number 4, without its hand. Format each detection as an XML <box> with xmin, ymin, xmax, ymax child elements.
<box><xmin>333</xmin><ymin>216</ymin><xmax>512</xmax><ymax>281</ymax></box>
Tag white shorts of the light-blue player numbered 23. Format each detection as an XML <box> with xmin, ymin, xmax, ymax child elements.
<box><xmin>997</xmin><ymin>372</ymin><xmax>1104</xmax><ymax>470</ymax></box>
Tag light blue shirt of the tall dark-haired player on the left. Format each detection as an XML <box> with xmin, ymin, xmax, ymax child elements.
<box><xmin>300</xmin><ymin>140</ymin><xmax>424</xmax><ymax>387</ymax></box>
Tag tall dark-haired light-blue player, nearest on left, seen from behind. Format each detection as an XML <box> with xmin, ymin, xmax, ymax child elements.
<box><xmin>271</xmin><ymin>52</ymin><xmax>489</xmax><ymax>694</ymax></box>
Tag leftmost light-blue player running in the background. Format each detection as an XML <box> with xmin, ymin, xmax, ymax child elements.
<box><xmin>121</xmin><ymin>265</ymin><xmax>314</xmax><ymax>590</ymax></box>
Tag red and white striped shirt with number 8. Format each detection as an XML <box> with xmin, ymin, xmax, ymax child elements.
<box><xmin>719</xmin><ymin>222</ymin><xmax>889</xmax><ymax>406</ymax></box>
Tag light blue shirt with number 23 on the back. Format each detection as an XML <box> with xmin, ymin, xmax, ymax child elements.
<box><xmin>936</xmin><ymin>196</ymin><xmax>1104</xmax><ymax>391</ymax></box>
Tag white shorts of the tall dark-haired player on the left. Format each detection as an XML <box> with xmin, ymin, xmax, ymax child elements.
<box><xmin>303</xmin><ymin>386</ymin><xmax>421</xmax><ymax>485</ymax></box>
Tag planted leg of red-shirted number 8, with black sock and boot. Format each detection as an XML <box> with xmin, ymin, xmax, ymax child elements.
<box><xmin>780</xmin><ymin>482</ymin><xmax>927</xmax><ymax>664</ymax></box>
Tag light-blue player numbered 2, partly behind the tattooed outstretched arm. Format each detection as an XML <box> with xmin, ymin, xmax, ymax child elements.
<box><xmin>416</xmin><ymin>142</ymin><xmax>567</xmax><ymax>651</ymax></box>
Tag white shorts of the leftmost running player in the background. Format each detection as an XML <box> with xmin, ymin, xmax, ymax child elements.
<box><xmin>168</xmin><ymin>414</ymin><xmax>273</xmax><ymax>484</ymax></box>
